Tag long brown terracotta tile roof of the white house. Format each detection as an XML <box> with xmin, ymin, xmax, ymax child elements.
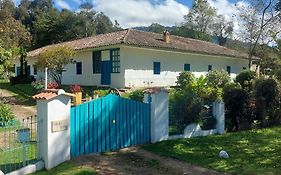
<box><xmin>27</xmin><ymin>29</ymin><xmax>247</xmax><ymax>58</ymax></box>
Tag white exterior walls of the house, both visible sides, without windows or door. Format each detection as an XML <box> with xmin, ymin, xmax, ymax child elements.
<box><xmin>19</xmin><ymin>45</ymin><xmax>248</xmax><ymax>88</ymax></box>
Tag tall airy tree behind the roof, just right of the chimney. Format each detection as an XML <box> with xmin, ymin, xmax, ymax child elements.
<box><xmin>184</xmin><ymin>0</ymin><xmax>216</xmax><ymax>33</ymax></box>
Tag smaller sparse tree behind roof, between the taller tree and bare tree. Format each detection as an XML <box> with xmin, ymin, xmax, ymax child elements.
<box><xmin>211</xmin><ymin>15</ymin><xmax>234</xmax><ymax>46</ymax></box>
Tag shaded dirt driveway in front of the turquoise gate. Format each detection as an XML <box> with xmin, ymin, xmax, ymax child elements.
<box><xmin>72</xmin><ymin>147</ymin><xmax>226</xmax><ymax>175</ymax></box>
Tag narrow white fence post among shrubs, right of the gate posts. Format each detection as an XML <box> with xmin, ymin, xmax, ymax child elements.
<box><xmin>213</xmin><ymin>101</ymin><xmax>225</xmax><ymax>134</ymax></box>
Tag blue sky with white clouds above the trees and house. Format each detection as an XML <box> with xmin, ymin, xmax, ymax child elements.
<box><xmin>14</xmin><ymin>0</ymin><xmax>246</xmax><ymax>28</ymax></box>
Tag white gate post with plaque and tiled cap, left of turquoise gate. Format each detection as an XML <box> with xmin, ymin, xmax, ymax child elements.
<box><xmin>33</xmin><ymin>90</ymin><xmax>73</xmax><ymax>170</ymax></box>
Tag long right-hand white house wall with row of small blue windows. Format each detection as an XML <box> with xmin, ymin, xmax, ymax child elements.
<box><xmin>121</xmin><ymin>47</ymin><xmax>248</xmax><ymax>87</ymax></box>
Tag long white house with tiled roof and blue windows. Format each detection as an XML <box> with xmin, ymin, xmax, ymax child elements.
<box><xmin>16</xmin><ymin>29</ymin><xmax>248</xmax><ymax>88</ymax></box>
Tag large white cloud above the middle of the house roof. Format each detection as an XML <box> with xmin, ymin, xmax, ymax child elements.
<box><xmin>93</xmin><ymin>0</ymin><xmax>189</xmax><ymax>28</ymax></box>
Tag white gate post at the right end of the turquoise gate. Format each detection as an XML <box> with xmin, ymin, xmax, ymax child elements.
<box><xmin>144</xmin><ymin>88</ymin><xmax>169</xmax><ymax>143</ymax></box>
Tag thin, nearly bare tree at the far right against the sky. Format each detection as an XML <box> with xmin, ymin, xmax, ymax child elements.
<box><xmin>238</xmin><ymin>0</ymin><xmax>280</xmax><ymax>68</ymax></box>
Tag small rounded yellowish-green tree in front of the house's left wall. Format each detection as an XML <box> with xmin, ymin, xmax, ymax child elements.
<box><xmin>36</xmin><ymin>46</ymin><xmax>75</xmax><ymax>85</ymax></box>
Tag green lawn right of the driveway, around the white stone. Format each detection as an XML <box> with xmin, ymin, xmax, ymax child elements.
<box><xmin>144</xmin><ymin>127</ymin><xmax>281</xmax><ymax>175</ymax></box>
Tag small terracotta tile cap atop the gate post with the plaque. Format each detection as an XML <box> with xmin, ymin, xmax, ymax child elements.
<box><xmin>32</xmin><ymin>89</ymin><xmax>75</xmax><ymax>100</ymax></box>
